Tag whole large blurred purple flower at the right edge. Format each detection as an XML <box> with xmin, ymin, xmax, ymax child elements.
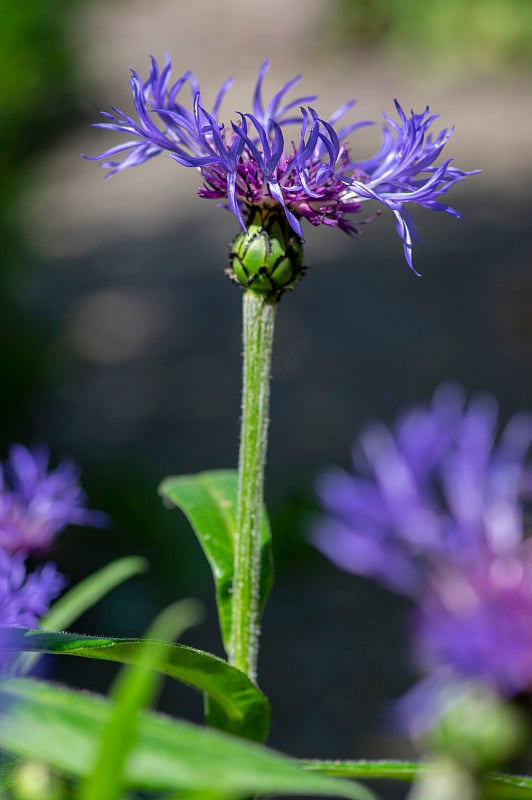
<box><xmin>312</xmin><ymin>385</ymin><xmax>532</xmax><ymax>720</ymax></box>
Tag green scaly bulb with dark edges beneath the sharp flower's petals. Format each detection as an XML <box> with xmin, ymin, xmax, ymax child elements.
<box><xmin>227</xmin><ymin>207</ymin><xmax>304</xmax><ymax>298</ymax></box>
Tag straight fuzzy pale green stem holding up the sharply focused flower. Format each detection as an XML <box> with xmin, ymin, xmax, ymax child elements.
<box><xmin>230</xmin><ymin>289</ymin><xmax>277</xmax><ymax>681</ymax></box>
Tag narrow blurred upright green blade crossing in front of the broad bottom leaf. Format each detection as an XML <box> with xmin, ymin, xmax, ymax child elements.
<box><xmin>79</xmin><ymin>600</ymin><xmax>202</xmax><ymax>800</ymax></box>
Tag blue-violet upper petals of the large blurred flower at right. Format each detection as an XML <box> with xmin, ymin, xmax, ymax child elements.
<box><xmin>312</xmin><ymin>385</ymin><xmax>532</xmax><ymax>597</ymax></box>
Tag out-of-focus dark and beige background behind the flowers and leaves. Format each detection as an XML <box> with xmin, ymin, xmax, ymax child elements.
<box><xmin>0</xmin><ymin>0</ymin><xmax>532</xmax><ymax>776</ymax></box>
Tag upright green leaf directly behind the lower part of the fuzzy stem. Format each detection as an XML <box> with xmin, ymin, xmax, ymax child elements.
<box><xmin>159</xmin><ymin>470</ymin><xmax>273</xmax><ymax>655</ymax></box>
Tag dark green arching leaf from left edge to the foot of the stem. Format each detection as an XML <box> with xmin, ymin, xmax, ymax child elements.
<box><xmin>2</xmin><ymin>628</ymin><xmax>270</xmax><ymax>742</ymax></box>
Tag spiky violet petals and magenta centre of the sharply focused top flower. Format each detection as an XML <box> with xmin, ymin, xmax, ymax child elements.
<box><xmin>84</xmin><ymin>57</ymin><xmax>475</xmax><ymax>271</ymax></box>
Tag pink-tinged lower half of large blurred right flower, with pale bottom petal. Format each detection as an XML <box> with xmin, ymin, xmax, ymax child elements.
<box><xmin>396</xmin><ymin>540</ymin><xmax>532</xmax><ymax>737</ymax></box>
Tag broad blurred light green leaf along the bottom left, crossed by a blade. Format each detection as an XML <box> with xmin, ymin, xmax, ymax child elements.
<box><xmin>0</xmin><ymin>680</ymin><xmax>373</xmax><ymax>800</ymax></box>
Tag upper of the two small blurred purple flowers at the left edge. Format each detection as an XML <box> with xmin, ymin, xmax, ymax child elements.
<box><xmin>0</xmin><ymin>445</ymin><xmax>106</xmax><ymax>555</ymax></box>
